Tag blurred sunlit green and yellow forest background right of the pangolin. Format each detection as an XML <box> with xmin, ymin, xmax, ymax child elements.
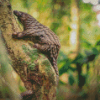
<box><xmin>0</xmin><ymin>0</ymin><xmax>100</xmax><ymax>100</ymax></box>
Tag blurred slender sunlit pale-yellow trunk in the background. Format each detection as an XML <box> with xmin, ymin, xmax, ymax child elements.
<box><xmin>69</xmin><ymin>0</ymin><xmax>80</xmax><ymax>58</ymax></box>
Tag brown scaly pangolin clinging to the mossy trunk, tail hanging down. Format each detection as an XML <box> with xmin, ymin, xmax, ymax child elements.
<box><xmin>12</xmin><ymin>10</ymin><xmax>60</xmax><ymax>83</ymax></box>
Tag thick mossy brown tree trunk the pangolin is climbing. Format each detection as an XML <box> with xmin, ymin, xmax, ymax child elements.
<box><xmin>0</xmin><ymin>0</ymin><xmax>57</xmax><ymax>100</ymax></box>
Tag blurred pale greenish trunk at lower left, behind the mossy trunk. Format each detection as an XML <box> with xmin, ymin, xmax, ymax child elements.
<box><xmin>0</xmin><ymin>31</ymin><xmax>21</xmax><ymax>100</ymax></box>
